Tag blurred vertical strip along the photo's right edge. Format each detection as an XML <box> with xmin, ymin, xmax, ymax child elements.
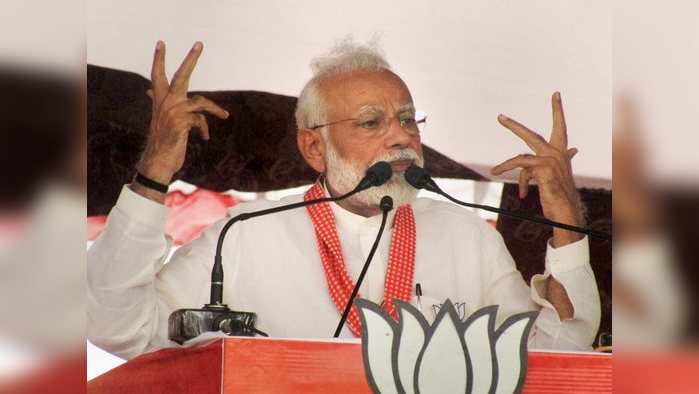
<box><xmin>612</xmin><ymin>0</ymin><xmax>699</xmax><ymax>393</ymax></box>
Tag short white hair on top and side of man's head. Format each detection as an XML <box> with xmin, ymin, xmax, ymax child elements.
<box><xmin>296</xmin><ymin>38</ymin><xmax>391</xmax><ymax>131</ymax></box>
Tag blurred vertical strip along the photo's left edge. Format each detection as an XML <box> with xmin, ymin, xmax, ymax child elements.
<box><xmin>0</xmin><ymin>1</ymin><xmax>87</xmax><ymax>393</ymax></box>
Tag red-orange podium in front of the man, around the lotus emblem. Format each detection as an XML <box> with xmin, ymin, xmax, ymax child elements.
<box><xmin>87</xmin><ymin>337</ymin><xmax>612</xmax><ymax>394</ymax></box>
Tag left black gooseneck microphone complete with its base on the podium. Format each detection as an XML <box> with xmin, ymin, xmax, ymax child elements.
<box><xmin>168</xmin><ymin>161</ymin><xmax>393</xmax><ymax>344</ymax></box>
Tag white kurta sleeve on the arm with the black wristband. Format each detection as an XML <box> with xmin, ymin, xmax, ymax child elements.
<box><xmin>87</xmin><ymin>186</ymin><xmax>230</xmax><ymax>358</ymax></box>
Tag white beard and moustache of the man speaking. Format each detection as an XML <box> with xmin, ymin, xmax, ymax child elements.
<box><xmin>325</xmin><ymin>138</ymin><xmax>424</xmax><ymax>208</ymax></box>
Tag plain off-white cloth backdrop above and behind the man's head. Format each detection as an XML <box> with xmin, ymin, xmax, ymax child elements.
<box><xmin>87</xmin><ymin>0</ymin><xmax>612</xmax><ymax>179</ymax></box>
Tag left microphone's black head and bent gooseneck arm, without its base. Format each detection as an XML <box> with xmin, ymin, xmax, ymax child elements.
<box><xmin>206</xmin><ymin>161</ymin><xmax>393</xmax><ymax>308</ymax></box>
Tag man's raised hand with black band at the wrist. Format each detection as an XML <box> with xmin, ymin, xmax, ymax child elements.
<box><xmin>137</xmin><ymin>41</ymin><xmax>229</xmax><ymax>202</ymax></box>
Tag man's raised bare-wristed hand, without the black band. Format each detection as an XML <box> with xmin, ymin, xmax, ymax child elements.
<box><xmin>491</xmin><ymin>92</ymin><xmax>583</xmax><ymax>247</ymax></box>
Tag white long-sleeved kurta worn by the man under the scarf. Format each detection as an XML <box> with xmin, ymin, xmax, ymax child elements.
<box><xmin>88</xmin><ymin>186</ymin><xmax>600</xmax><ymax>358</ymax></box>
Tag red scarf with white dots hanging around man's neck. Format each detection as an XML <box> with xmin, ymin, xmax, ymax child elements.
<box><xmin>304</xmin><ymin>182</ymin><xmax>415</xmax><ymax>336</ymax></box>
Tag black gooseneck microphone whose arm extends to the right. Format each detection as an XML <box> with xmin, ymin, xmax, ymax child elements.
<box><xmin>405</xmin><ymin>164</ymin><xmax>612</xmax><ymax>241</ymax></box>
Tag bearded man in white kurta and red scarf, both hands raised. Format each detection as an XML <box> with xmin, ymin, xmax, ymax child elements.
<box><xmin>88</xmin><ymin>42</ymin><xmax>600</xmax><ymax>358</ymax></box>
